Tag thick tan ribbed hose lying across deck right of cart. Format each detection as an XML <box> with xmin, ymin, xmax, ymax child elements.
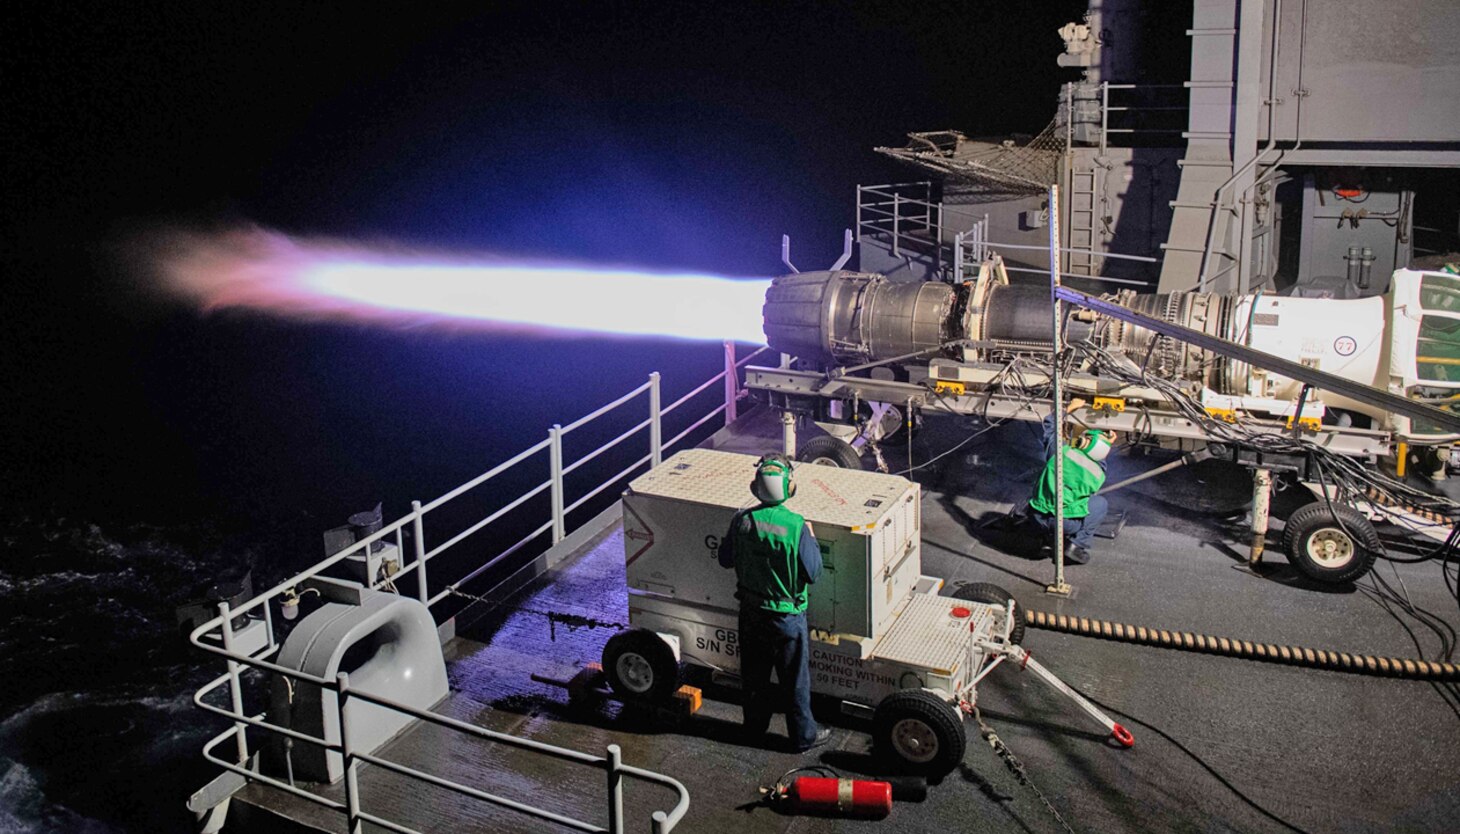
<box><xmin>1023</xmin><ymin>609</ymin><xmax>1460</xmax><ymax>681</ymax></box>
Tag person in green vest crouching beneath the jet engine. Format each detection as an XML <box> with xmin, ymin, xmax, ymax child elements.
<box><xmin>1029</xmin><ymin>397</ymin><xmax>1115</xmax><ymax>565</ymax></box>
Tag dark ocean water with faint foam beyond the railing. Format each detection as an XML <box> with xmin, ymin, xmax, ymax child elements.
<box><xmin>0</xmin><ymin>514</ymin><xmax>230</xmax><ymax>834</ymax></box>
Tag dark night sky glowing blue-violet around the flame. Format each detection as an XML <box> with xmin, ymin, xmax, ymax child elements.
<box><xmin>0</xmin><ymin>1</ymin><xmax>1083</xmax><ymax>528</ymax></box>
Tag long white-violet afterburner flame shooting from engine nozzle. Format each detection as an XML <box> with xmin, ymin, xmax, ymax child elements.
<box><xmin>147</xmin><ymin>229</ymin><xmax>769</xmax><ymax>345</ymax></box>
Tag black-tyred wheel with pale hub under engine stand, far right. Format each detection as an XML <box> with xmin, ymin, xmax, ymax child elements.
<box><xmin>1283</xmin><ymin>501</ymin><xmax>1383</xmax><ymax>583</ymax></box>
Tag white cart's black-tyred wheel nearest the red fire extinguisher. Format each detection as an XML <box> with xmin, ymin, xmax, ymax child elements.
<box><xmin>872</xmin><ymin>689</ymin><xmax>968</xmax><ymax>777</ymax></box>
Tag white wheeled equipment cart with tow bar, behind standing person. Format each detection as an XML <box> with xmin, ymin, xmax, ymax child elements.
<box><xmin>603</xmin><ymin>450</ymin><xmax>1134</xmax><ymax>776</ymax></box>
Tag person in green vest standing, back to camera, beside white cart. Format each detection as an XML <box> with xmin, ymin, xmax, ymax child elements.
<box><xmin>718</xmin><ymin>454</ymin><xmax>831</xmax><ymax>752</ymax></box>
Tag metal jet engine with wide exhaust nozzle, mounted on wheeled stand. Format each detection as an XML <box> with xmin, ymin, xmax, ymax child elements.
<box><xmin>764</xmin><ymin>269</ymin><xmax>1460</xmax><ymax>431</ymax></box>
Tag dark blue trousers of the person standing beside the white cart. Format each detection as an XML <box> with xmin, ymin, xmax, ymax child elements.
<box><xmin>740</xmin><ymin>608</ymin><xmax>818</xmax><ymax>749</ymax></box>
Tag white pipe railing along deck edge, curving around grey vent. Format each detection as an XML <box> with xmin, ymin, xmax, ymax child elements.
<box><xmin>190</xmin><ymin>342</ymin><xmax>767</xmax><ymax>834</ymax></box>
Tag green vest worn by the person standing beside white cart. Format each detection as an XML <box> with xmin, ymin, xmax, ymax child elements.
<box><xmin>734</xmin><ymin>505</ymin><xmax>806</xmax><ymax>613</ymax></box>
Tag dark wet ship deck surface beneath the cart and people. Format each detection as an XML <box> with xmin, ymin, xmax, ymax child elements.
<box><xmin>233</xmin><ymin>408</ymin><xmax>1460</xmax><ymax>834</ymax></box>
